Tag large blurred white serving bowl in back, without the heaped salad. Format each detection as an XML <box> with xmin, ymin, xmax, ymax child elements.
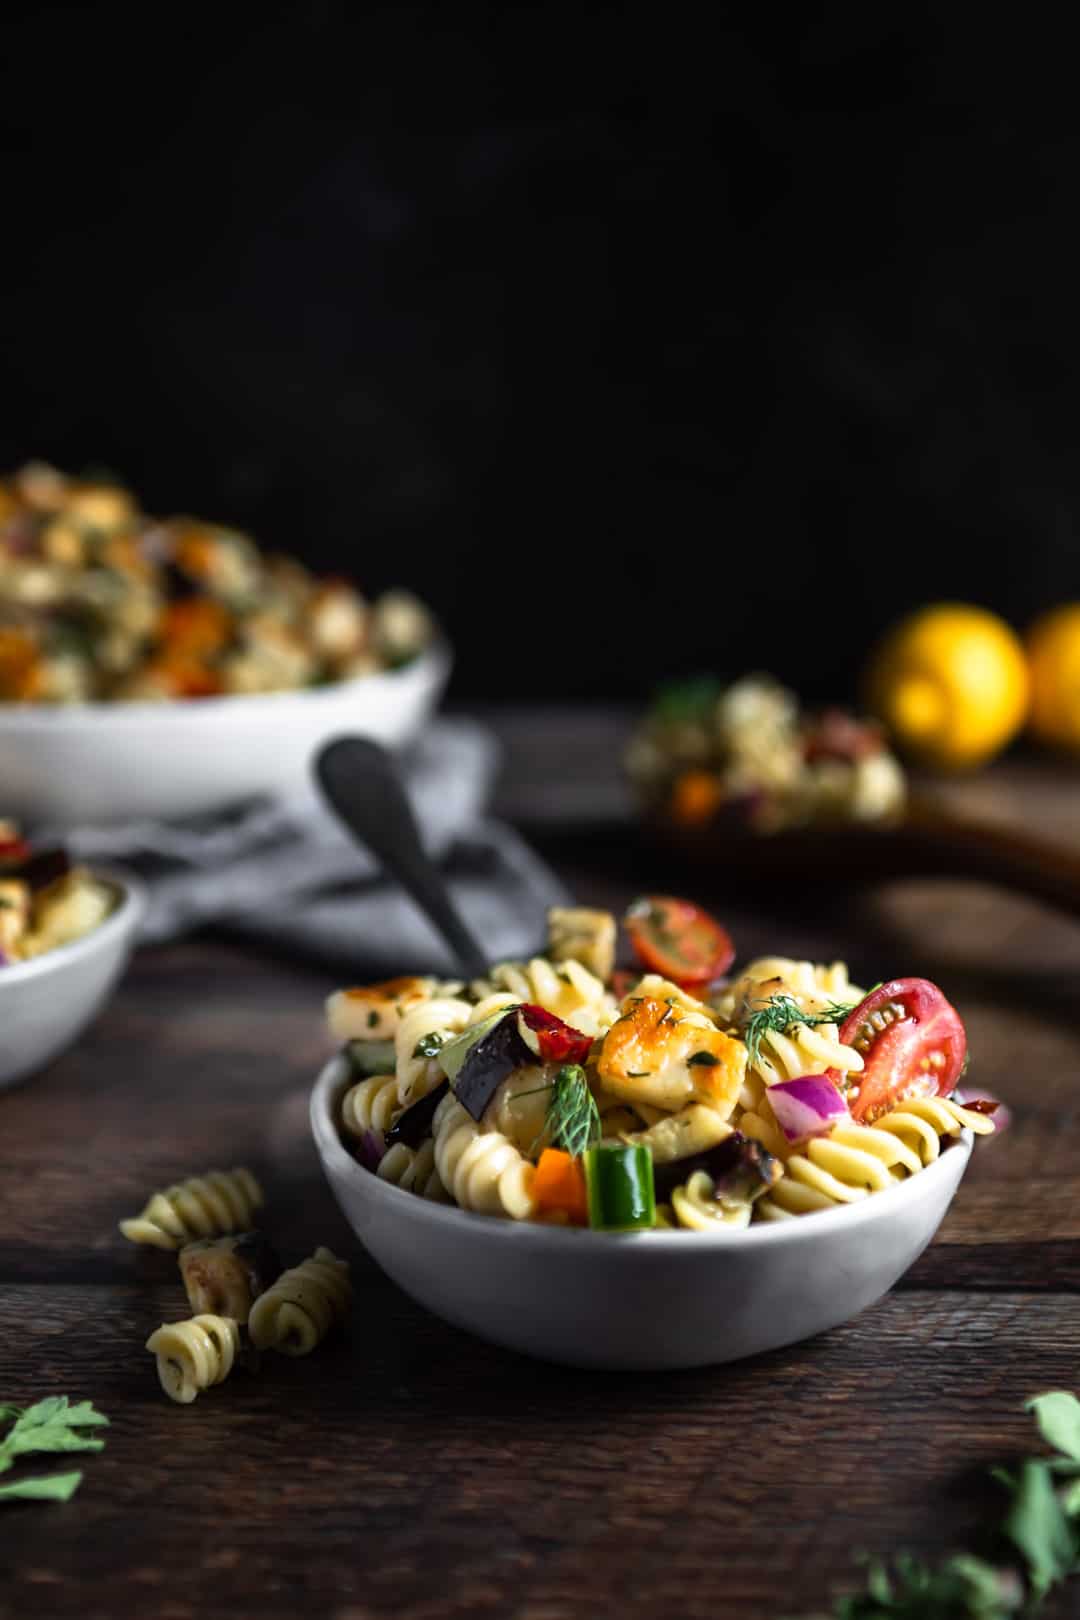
<box><xmin>0</xmin><ymin>643</ymin><xmax>450</xmax><ymax>826</ymax></box>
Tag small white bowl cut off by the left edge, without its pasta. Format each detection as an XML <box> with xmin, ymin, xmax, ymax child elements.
<box><xmin>0</xmin><ymin>867</ymin><xmax>144</xmax><ymax>1090</ymax></box>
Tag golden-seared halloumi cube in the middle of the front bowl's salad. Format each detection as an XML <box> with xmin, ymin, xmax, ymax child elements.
<box><xmin>597</xmin><ymin>996</ymin><xmax>746</xmax><ymax>1119</ymax></box>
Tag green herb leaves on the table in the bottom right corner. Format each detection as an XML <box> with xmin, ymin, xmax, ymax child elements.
<box><xmin>799</xmin><ymin>1390</ymin><xmax>1080</xmax><ymax>1620</ymax></box>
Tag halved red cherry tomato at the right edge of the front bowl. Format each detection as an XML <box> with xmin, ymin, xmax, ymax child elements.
<box><xmin>840</xmin><ymin>978</ymin><xmax>968</xmax><ymax>1124</ymax></box>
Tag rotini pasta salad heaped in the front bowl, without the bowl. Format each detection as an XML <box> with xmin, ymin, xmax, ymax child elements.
<box><xmin>325</xmin><ymin>896</ymin><xmax>996</xmax><ymax>1224</ymax></box>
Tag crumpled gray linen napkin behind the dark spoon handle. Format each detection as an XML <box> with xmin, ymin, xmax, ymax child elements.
<box><xmin>63</xmin><ymin>721</ymin><xmax>565</xmax><ymax>975</ymax></box>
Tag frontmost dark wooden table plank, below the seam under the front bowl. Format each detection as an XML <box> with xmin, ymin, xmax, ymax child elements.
<box><xmin>0</xmin><ymin>1289</ymin><xmax>1080</xmax><ymax>1620</ymax></box>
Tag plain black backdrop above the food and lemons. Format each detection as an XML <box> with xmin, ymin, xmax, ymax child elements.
<box><xmin>0</xmin><ymin>5</ymin><xmax>1080</xmax><ymax>700</ymax></box>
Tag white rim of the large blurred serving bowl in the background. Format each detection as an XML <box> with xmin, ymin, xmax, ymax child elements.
<box><xmin>0</xmin><ymin>632</ymin><xmax>452</xmax><ymax>734</ymax></box>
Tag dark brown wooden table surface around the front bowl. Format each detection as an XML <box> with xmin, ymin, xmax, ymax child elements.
<box><xmin>0</xmin><ymin>727</ymin><xmax>1080</xmax><ymax>1620</ymax></box>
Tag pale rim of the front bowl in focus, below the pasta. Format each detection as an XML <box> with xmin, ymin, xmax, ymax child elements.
<box><xmin>309</xmin><ymin>1053</ymin><xmax>975</xmax><ymax>1256</ymax></box>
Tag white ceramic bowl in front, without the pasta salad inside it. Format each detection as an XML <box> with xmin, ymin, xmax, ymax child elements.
<box><xmin>311</xmin><ymin>1058</ymin><xmax>972</xmax><ymax>1371</ymax></box>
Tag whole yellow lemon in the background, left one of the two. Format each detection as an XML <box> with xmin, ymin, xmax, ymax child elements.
<box><xmin>866</xmin><ymin>603</ymin><xmax>1028</xmax><ymax>770</ymax></box>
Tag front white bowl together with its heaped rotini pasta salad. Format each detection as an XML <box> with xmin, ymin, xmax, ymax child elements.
<box><xmin>313</xmin><ymin>896</ymin><xmax>996</xmax><ymax>1367</ymax></box>
